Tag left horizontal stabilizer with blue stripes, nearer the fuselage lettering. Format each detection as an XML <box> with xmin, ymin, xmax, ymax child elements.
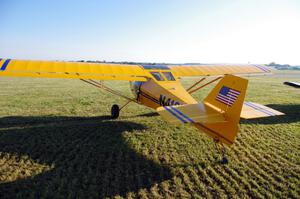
<box><xmin>156</xmin><ymin>103</ymin><xmax>225</xmax><ymax>123</ymax></box>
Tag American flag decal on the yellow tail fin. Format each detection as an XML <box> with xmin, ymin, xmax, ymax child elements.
<box><xmin>216</xmin><ymin>86</ymin><xmax>241</xmax><ymax>106</ymax></box>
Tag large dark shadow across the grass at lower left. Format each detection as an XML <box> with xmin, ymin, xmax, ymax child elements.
<box><xmin>0</xmin><ymin>117</ymin><xmax>172</xmax><ymax>198</ymax></box>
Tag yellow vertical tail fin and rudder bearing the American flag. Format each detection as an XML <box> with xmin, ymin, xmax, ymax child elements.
<box><xmin>194</xmin><ymin>75</ymin><xmax>248</xmax><ymax>145</ymax></box>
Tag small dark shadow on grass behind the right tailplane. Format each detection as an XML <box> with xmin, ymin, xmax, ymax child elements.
<box><xmin>241</xmin><ymin>104</ymin><xmax>300</xmax><ymax>124</ymax></box>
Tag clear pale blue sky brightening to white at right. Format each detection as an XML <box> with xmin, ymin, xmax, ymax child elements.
<box><xmin>0</xmin><ymin>0</ymin><xmax>300</xmax><ymax>65</ymax></box>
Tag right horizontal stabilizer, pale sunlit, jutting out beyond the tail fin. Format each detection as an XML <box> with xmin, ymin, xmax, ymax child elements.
<box><xmin>241</xmin><ymin>102</ymin><xmax>284</xmax><ymax>119</ymax></box>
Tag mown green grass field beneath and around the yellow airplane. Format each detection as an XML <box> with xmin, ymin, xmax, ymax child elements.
<box><xmin>0</xmin><ymin>72</ymin><xmax>300</xmax><ymax>198</ymax></box>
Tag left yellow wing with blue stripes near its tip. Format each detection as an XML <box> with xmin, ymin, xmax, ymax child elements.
<box><xmin>0</xmin><ymin>59</ymin><xmax>149</xmax><ymax>81</ymax></box>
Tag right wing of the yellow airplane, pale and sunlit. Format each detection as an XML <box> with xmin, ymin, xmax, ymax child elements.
<box><xmin>170</xmin><ymin>64</ymin><xmax>271</xmax><ymax>77</ymax></box>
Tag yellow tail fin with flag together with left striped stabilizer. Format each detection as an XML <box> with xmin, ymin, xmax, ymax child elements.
<box><xmin>157</xmin><ymin>75</ymin><xmax>248</xmax><ymax>145</ymax></box>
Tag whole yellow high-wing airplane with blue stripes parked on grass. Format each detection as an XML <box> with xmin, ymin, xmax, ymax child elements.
<box><xmin>0</xmin><ymin>59</ymin><xmax>283</xmax><ymax>148</ymax></box>
